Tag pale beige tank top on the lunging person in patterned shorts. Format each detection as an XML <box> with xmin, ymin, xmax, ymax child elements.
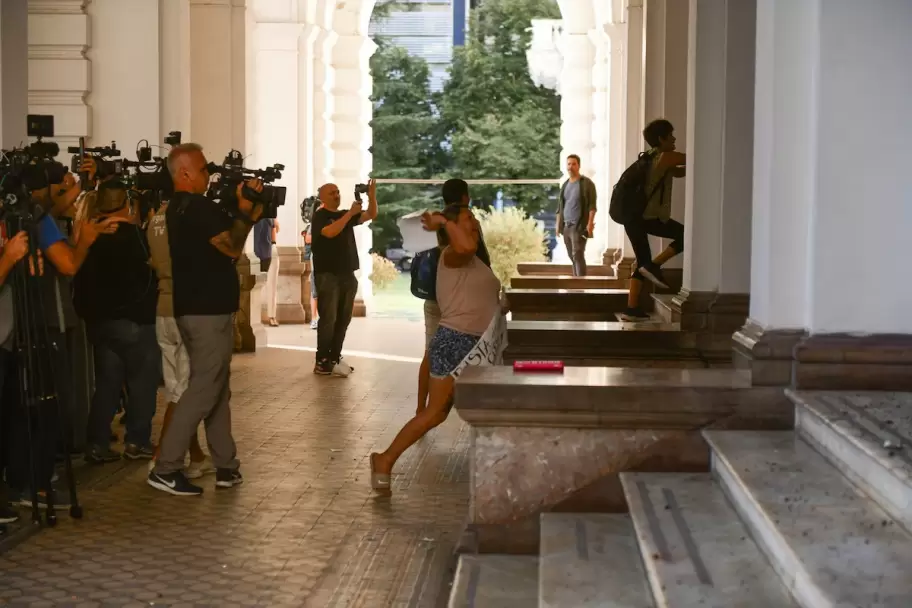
<box><xmin>437</xmin><ymin>249</ymin><xmax>500</xmax><ymax>336</ymax></box>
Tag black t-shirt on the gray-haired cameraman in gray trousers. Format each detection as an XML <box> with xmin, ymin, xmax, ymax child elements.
<box><xmin>165</xmin><ymin>192</ymin><xmax>241</xmax><ymax>317</ymax></box>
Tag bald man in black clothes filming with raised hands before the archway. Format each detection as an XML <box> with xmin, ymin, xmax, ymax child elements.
<box><xmin>311</xmin><ymin>180</ymin><xmax>377</xmax><ymax>377</ymax></box>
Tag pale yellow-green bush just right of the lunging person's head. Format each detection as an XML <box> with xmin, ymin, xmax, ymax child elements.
<box><xmin>476</xmin><ymin>207</ymin><xmax>547</xmax><ymax>288</ymax></box>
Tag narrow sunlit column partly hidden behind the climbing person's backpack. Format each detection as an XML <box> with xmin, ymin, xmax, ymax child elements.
<box><xmin>615</xmin><ymin>0</ymin><xmax>646</xmax><ymax>279</ymax></box>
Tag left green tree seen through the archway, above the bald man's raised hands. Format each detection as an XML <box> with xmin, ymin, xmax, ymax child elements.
<box><xmin>371</xmin><ymin>15</ymin><xmax>447</xmax><ymax>254</ymax></box>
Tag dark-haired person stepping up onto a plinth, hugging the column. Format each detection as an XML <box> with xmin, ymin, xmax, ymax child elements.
<box><xmin>621</xmin><ymin>119</ymin><xmax>687</xmax><ymax>321</ymax></box>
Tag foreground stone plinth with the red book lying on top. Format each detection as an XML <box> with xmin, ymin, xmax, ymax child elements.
<box><xmin>456</xmin><ymin>367</ymin><xmax>794</xmax><ymax>553</ymax></box>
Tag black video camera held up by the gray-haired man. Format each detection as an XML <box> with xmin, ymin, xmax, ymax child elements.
<box><xmin>206</xmin><ymin>150</ymin><xmax>286</xmax><ymax>219</ymax></box>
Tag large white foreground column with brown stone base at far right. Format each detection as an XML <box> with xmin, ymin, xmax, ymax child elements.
<box><xmin>736</xmin><ymin>0</ymin><xmax>912</xmax><ymax>391</ymax></box>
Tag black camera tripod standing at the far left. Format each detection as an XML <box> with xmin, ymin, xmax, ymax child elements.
<box><xmin>6</xmin><ymin>216</ymin><xmax>82</xmax><ymax>527</ymax></box>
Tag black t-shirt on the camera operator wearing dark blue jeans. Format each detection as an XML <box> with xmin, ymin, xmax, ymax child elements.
<box><xmin>73</xmin><ymin>224</ymin><xmax>158</xmax><ymax>325</ymax></box>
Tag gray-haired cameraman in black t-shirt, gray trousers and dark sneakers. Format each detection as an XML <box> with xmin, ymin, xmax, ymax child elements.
<box><xmin>148</xmin><ymin>144</ymin><xmax>263</xmax><ymax>496</ymax></box>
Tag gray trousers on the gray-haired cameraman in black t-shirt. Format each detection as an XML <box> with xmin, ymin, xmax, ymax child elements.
<box><xmin>155</xmin><ymin>315</ymin><xmax>240</xmax><ymax>475</ymax></box>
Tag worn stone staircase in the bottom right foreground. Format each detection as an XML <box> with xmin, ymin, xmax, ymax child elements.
<box><xmin>449</xmin><ymin>392</ymin><xmax>912</xmax><ymax>608</ymax></box>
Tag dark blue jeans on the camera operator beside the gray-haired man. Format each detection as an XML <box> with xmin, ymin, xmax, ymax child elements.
<box><xmin>86</xmin><ymin>319</ymin><xmax>161</xmax><ymax>447</ymax></box>
